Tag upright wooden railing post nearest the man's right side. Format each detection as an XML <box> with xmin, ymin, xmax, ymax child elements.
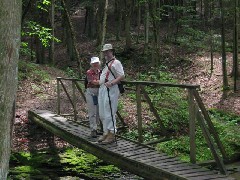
<box><xmin>136</xmin><ymin>84</ymin><xmax>143</xmax><ymax>143</ymax></box>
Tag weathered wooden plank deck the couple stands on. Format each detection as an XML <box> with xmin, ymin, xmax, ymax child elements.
<box><xmin>28</xmin><ymin>110</ymin><xmax>234</xmax><ymax>180</ymax></box>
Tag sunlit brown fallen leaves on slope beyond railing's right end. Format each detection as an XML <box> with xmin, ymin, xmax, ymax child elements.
<box><xmin>172</xmin><ymin>54</ymin><xmax>240</xmax><ymax>114</ymax></box>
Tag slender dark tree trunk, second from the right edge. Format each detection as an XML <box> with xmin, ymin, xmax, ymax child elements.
<box><xmin>219</xmin><ymin>0</ymin><xmax>228</xmax><ymax>91</ymax></box>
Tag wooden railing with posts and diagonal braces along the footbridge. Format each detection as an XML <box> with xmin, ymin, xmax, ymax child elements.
<box><xmin>57</xmin><ymin>77</ymin><xmax>227</xmax><ymax>174</ymax></box>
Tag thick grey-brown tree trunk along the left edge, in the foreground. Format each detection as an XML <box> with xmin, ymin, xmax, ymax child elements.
<box><xmin>0</xmin><ymin>0</ymin><xmax>22</xmax><ymax>180</ymax></box>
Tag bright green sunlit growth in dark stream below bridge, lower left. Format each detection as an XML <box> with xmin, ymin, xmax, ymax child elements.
<box><xmin>10</xmin><ymin>148</ymin><xmax>120</xmax><ymax>179</ymax></box>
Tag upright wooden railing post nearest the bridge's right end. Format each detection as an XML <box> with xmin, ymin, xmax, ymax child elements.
<box><xmin>188</xmin><ymin>89</ymin><xmax>196</xmax><ymax>164</ymax></box>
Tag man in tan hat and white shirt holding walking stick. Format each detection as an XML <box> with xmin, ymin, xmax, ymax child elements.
<box><xmin>98</xmin><ymin>44</ymin><xmax>125</xmax><ymax>144</ymax></box>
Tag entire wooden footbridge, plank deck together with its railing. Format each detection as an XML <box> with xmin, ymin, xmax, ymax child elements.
<box><xmin>28</xmin><ymin>78</ymin><xmax>234</xmax><ymax>180</ymax></box>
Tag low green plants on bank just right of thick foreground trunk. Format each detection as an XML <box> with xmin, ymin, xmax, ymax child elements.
<box><xmin>18</xmin><ymin>61</ymin><xmax>50</xmax><ymax>83</ymax></box>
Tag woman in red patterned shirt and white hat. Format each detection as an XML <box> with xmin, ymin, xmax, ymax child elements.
<box><xmin>85</xmin><ymin>57</ymin><xmax>101</xmax><ymax>138</ymax></box>
